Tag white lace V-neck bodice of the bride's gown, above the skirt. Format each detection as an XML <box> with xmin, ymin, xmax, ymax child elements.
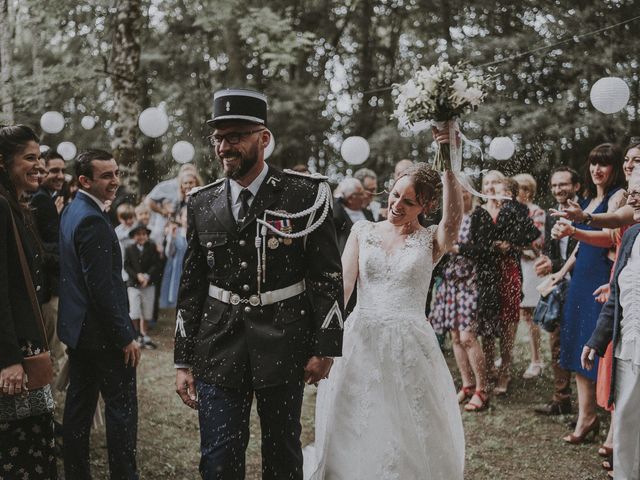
<box><xmin>352</xmin><ymin>221</ymin><xmax>437</xmax><ymax>320</ymax></box>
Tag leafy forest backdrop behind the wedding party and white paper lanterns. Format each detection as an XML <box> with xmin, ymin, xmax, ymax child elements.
<box><xmin>0</xmin><ymin>0</ymin><xmax>640</xmax><ymax>200</ymax></box>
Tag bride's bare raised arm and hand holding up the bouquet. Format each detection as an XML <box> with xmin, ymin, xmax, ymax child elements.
<box><xmin>433</xmin><ymin>129</ymin><xmax>464</xmax><ymax>262</ymax></box>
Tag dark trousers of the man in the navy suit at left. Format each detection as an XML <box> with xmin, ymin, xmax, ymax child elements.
<box><xmin>63</xmin><ymin>350</ymin><xmax>138</xmax><ymax>480</ymax></box>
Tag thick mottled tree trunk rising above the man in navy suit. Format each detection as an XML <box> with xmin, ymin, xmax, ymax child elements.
<box><xmin>109</xmin><ymin>0</ymin><xmax>142</xmax><ymax>194</ymax></box>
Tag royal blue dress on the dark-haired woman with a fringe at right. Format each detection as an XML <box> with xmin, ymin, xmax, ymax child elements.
<box><xmin>560</xmin><ymin>188</ymin><xmax>619</xmax><ymax>382</ymax></box>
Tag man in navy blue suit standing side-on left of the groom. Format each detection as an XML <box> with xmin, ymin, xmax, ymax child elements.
<box><xmin>58</xmin><ymin>150</ymin><xmax>140</xmax><ymax>479</ymax></box>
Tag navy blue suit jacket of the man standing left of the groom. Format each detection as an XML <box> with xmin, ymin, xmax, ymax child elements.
<box><xmin>58</xmin><ymin>192</ymin><xmax>135</xmax><ymax>349</ymax></box>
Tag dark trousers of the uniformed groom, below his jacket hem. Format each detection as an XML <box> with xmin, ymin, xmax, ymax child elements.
<box><xmin>197</xmin><ymin>381</ymin><xmax>304</xmax><ymax>480</ymax></box>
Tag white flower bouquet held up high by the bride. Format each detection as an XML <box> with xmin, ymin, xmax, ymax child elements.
<box><xmin>394</xmin><ymin>62</ymin><xmax>488</xmax><ymax>171</ymax></box>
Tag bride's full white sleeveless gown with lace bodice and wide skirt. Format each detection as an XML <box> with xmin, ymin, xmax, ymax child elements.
<box><xmin>305</xmin><ymin>221</ymin><xmax>464</xmax><ymax>480</ymax></box>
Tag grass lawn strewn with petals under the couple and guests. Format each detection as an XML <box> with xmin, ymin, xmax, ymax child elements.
<box><xmin>61</xmin><ymin>317</ymin><xmax>608</xmax><ymax>480</ymax></box>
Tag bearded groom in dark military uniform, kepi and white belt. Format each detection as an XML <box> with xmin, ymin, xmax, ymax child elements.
<box><xmin>174</xmin><ymin>90</ymin><xmax>343</xmax><ymax>480</ymax></box>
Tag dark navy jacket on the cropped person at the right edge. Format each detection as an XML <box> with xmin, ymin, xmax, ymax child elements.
<box><xmin>586</xmin><ymin>224</ymin><xmax>640</xmax><ymax>404</ymax></box>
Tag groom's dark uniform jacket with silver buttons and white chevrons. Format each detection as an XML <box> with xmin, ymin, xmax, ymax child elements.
<box><xmin>174</xmin><ymin>166</ymin><xmax>344</xmax><ymax>388</ymax></box>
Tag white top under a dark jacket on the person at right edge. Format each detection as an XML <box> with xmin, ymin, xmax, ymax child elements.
<box><xmin>615</xmin><ymin>235</ymin><xmax>640</xmax><ymax>365</ymax></box>
